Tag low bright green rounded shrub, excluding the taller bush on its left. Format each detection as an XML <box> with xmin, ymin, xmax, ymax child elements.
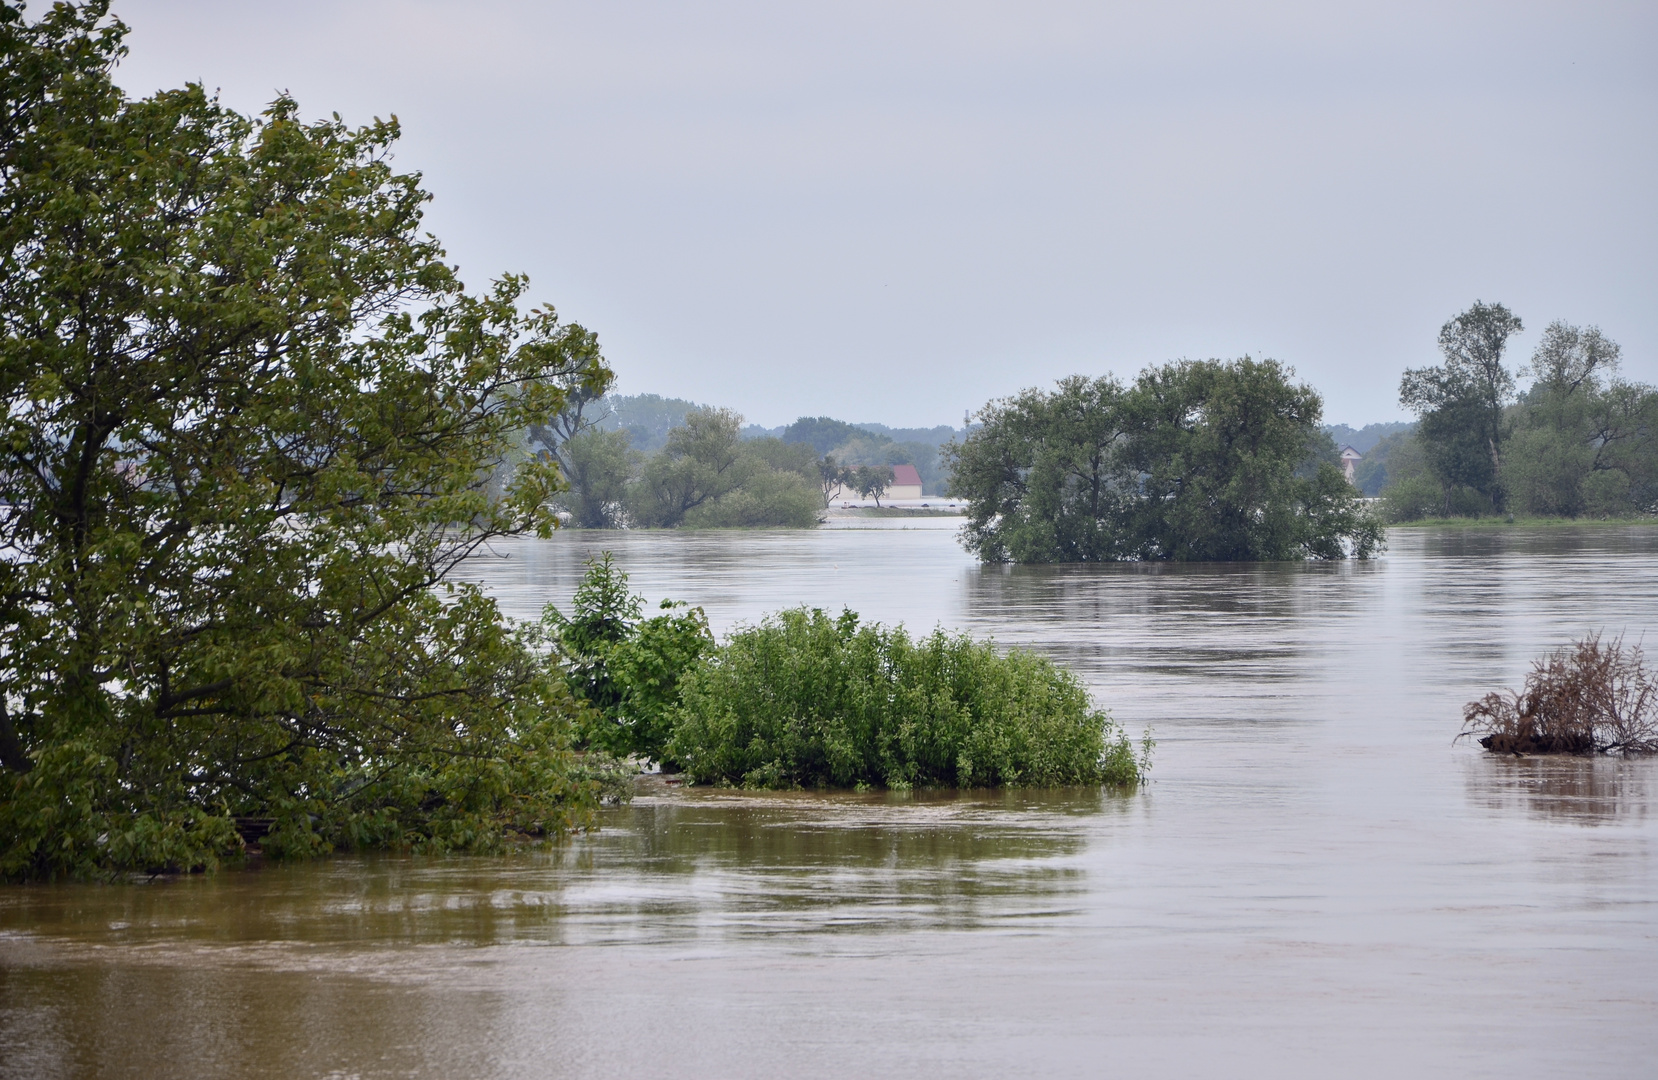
<box><xmin>668</xmin><ymin>607</ymin><xmax>1149</xmax><ymax>788</ymax></box>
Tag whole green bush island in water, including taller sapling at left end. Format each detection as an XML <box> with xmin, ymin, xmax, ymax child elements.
<box><xmin>545</xmin><ymin>554</ymin><xmax>1151</xmax><ymax>790</ymax></box>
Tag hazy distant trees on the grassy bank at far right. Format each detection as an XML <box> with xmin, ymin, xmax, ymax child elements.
<box><xmin>1355</xmin><ymin>302</ymin><xmax>1658</xmax><ymax>521</ymax></box>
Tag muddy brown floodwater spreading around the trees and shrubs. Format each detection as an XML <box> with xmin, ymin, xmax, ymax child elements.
<box><xmin>0</xmin><ymin>521</ymin><xmax>1658</xmax><ymax>1078</ymax></box>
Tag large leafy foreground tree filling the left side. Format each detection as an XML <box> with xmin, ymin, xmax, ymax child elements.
<box><xmin>0</xmin><ymin>2</ymin><xmax>610</xmax><ymax>878</ymax></box>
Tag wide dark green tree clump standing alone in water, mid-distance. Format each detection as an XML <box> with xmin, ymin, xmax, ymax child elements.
<box><xmin>948</xmin><ymin>357</ymin><xmax>1379</xmax><ymax>562</ymax></box>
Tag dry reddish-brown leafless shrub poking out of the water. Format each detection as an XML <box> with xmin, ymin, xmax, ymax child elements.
<box><xmin>1457</xmin><ymin>634</ymin><xmax>1658</xmax><ymax>753</ymax></box>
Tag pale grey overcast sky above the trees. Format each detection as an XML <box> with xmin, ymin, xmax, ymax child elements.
<box><xmin>110</xmin><ymin>0</ymin><xmax>1658</xmax><ymax>426</ymax></box>
